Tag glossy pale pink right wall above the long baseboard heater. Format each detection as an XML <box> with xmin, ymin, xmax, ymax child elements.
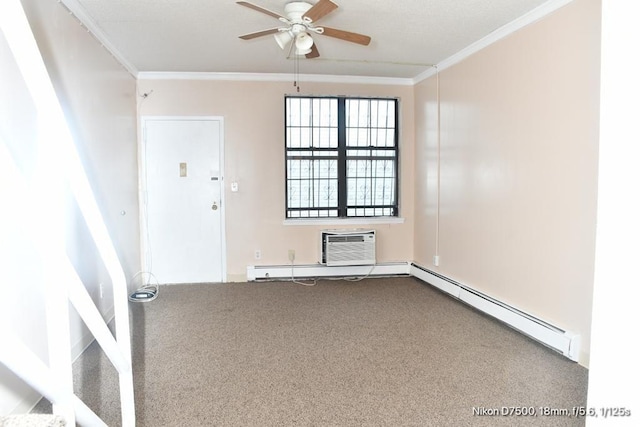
<box><xmin>414</xmin><ymin>0</ymin><xmax>600</xmax><ymax>364</ymax></box>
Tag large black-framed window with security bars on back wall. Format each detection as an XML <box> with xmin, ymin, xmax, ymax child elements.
<box><xmin>285</xmin><ymin>96</ymin><xmax>398</xmax><ymax>218</ymax></box>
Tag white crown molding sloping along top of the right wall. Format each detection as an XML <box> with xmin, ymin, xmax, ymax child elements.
<box><xmin>413</xmin><ymin>0</ymin><xmax>573</xmax><ymax>84</ymax></box>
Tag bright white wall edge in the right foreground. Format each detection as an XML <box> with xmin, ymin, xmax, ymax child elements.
<box><xmin>587</xmin><ymin>0</ymin><xmax>640</xmax><ymax>426</ymax></box>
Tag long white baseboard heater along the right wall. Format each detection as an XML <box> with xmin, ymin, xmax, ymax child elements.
<box><xmin>410</xmin><ymin>264</ymin><xmax>580</xmax><ymax>362</ymax></box>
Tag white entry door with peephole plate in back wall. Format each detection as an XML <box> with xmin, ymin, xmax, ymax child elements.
<box><xmin>141</xmin><ymin>118</ymin><xmax>225</xmax><ymax>284</ymax></box>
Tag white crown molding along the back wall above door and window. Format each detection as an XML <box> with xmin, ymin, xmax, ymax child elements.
<box><xmin>137</xmin><ymin>71</ymin><xmax>414</xmax><ymax>86</ymax></box>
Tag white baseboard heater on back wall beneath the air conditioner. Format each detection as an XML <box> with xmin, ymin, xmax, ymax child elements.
<box><xmin>247</xmin><ymin>262</ymin><xmax>411</xmax><ymax>282</ymax></box>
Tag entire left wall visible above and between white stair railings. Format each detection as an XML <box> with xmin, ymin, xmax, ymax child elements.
<box><xmin>0</xmin><ymin>0</ymin><xmax>140</xmax><ymax>415</ymax></box>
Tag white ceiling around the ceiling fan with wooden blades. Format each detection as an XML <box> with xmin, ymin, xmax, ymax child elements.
<box><xmin>63</xmin><ymin>0</ymin><xmax>553</xmax><ymax>79</ymax></box>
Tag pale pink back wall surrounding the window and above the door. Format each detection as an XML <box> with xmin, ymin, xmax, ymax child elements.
<box><xmin>138</xmin><ymin>79</ymin><xmax>414</xmax><ymax>281</ymax></box>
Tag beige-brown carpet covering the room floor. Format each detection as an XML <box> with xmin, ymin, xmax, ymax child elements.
<box><xmin>36</xmin><ymin>278</ymin><xmax>588</xmax><ymax>426</ymax></box>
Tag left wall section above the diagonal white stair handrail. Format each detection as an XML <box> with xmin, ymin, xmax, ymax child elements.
<box><xmin>22</xmin><ymin>0</ymin><xmax>140</xmax><ymax>277</ymax></box>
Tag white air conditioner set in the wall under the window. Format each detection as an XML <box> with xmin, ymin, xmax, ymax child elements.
<box><xmin>320</xmin><ymin>229</ymin><xmax>376</xmax><ymax>266</ymax></box>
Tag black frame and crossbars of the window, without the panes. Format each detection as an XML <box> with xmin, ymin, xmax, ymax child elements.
<box><xmin>284</xmin><ymin>95</ymin><xmax>400</xmax><ymax>221</ymax></box>
